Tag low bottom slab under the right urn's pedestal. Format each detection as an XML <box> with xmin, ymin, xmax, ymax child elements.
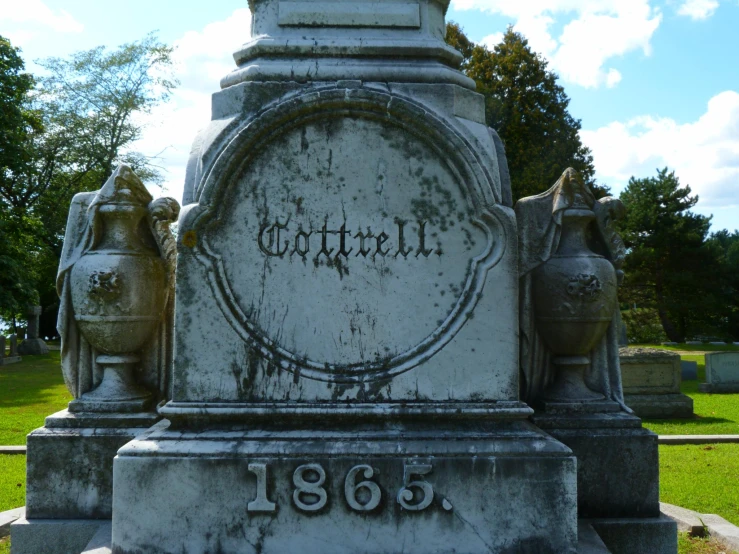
<box><xmin>590</xmin><ymin>514</ymin><xmax>677</xmax><ymax>554</ymax></box>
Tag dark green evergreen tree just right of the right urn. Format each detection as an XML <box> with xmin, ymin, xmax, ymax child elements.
<box><xmin>621</xmin><ymin>168</ymin><xmax>725</xmax><ymax>342</ymax></box>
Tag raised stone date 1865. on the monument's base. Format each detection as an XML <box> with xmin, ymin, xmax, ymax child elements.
<box><xmin>247</xmin><ymin>463</ymin><xmax>453</xmax><ymax>513</ymax></box>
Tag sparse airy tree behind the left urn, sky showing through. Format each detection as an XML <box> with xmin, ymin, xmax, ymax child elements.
<box><xmin>0</xmin><ymin>35</ymin><xmax>177</xmax><ymax>330</ymax></box>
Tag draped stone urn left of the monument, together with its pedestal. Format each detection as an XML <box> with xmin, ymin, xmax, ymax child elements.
<box><xmin>12</xmin><ymin>165</ymin><xmax>179</xmax><ymax>554</ymax></box>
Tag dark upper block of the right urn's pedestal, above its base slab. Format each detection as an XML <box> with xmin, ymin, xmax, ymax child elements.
<box><xmin>534</xmin><ymin>414</ymin><xmax>659</xmax><ymax>520</ymax></box>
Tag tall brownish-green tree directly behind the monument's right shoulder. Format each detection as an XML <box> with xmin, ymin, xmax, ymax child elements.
<box><xmin>446</xmin><ymin>23</ymin><xmax>608</xmax><ymax>200</ymax></box>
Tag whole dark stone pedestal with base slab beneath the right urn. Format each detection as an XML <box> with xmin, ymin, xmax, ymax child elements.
<box><xmin>532</xmin><ymin>403</ymin><xmax>677</xmax><ymax>554</ymax></box>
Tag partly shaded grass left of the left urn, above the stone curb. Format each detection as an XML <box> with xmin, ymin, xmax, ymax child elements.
<box><xmin>0</xmin><ymin>352</ymin><xmax>72</xmax><ymax>446</ymax></box>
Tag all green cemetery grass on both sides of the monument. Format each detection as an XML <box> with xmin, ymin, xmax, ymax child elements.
<box><xmin>0</xmin><ymin>345</ymin><xmax>739</xmax><ymax>554</ymax></box>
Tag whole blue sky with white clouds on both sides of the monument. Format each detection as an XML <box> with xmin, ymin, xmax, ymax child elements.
<box><xmin>0</xmin><ymin>0</ymin><xmax>739</xmax><ymax>230</ymax></box>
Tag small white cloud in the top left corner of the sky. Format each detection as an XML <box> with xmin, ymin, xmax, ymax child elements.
<box><xmin>0</xmin><ymin>0</ymin><xmax>84</xmax><ymax>43</ymax></box>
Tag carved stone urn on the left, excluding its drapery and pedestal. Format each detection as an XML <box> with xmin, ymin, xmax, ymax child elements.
<box><xmin>70</xmin><ymin>166</ymin><xmax>167</xmax><ymax>411</ymax></box>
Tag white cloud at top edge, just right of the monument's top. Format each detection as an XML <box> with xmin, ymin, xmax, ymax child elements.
<box><xmin>454</xmin><ymin>0</ymin><xmax>664</xmax><ymax>88</ymax></box>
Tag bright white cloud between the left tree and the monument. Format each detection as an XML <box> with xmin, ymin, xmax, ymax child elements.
<box><xmin>132</xmin><ymin>9</ymin><xmax>251</xmax><ymax>201</ymax></box>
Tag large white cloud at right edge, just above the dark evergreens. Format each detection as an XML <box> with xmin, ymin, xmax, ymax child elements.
<box><xmin>581</xmin><ymin>91</ymin><xmax>739</xmax><ymax>210</ymax></box>
